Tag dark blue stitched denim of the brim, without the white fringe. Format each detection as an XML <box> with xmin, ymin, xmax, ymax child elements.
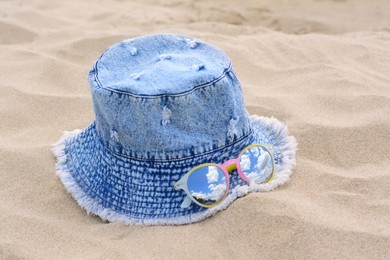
<box><xmin>62</xmin><ymin>123</ymin><xmax>254</xmax><ymax>222</ymax></box>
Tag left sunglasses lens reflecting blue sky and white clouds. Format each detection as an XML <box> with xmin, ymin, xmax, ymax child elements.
<box><xmin>187</xmin><ymin>165</ymin><xmax>227</xmax><ymax>205</ymax></box>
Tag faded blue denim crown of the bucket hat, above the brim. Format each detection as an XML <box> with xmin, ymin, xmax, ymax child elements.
<box><xmin>89</xmin><ymin>35</ymin><xmax>251</xmax><ymax>160</ymax></box>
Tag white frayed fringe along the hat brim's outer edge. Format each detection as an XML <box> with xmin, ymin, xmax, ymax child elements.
<box><xmin>52</xmin><ymin>115</ymin><xmax>298</xmax><ymax>225</ymax></box>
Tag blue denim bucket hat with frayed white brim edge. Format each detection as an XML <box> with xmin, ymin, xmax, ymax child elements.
<box><xmin>52</xmin><ymin>34</ymin><xmax>297</xmax><ymax>225</ymax></box>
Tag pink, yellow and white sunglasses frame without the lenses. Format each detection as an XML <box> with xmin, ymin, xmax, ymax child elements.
<box><xmin>174</xmin><ymin>144</ymin><xmax>275</xmax><ymax>208</ymax></box>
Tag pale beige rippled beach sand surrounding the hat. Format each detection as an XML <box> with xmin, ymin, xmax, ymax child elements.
<box><xmin>0</xmin><ymin>0</ymin><xmax>390</xmax><ymax>259</ymax></box>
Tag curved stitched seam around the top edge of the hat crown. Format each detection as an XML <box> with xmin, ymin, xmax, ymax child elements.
<box><xmin>94</xmin><ymin>58</ymin><xmax>232</xmax><ymax>99</ymax></box>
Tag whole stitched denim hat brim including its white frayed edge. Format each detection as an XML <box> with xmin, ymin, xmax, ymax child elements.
<box><xmin>52</xmin><ymin>115</ymin><xmax>297</xmax><ymax>225</ymax></box>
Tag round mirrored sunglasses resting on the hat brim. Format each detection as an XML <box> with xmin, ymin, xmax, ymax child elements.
<box><xmin>174</xmin><ymin>144</ymin><xmax>275</xmax><ymax>208</ymax></box>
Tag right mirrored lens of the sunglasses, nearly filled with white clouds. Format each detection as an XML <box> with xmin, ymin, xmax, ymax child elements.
<box><xmin>240</xmin><ymin>146</ymin><xmax>274</xmax><ymax>184</ymax></box>
